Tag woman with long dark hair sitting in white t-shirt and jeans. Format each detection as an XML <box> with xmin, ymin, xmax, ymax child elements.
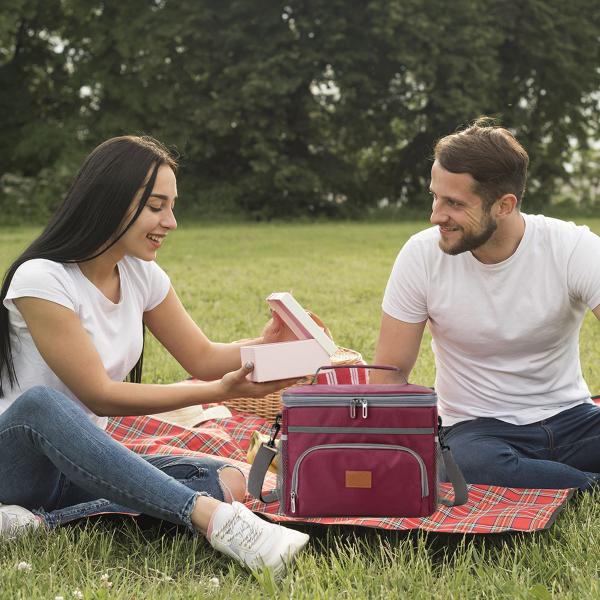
<box><xmin>0</xmin><ymin>136</ymin><xmax>308</xmax><ymax>572</ymax></box>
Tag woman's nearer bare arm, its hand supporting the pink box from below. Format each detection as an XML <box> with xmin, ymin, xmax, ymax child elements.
<box><xmin>13</xmin><ymin>297</ymin><xmax>295</xmax><ymax>416</ymax></box>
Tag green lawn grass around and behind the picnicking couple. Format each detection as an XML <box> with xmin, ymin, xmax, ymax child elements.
<box><xmin>0</xmin><ymin>220</ymin><xmax>600</xmax><ymax>600</ymax></box>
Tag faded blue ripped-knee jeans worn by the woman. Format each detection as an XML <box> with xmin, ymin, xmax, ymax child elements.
<box><xmin>0</xmin><ymin>387</ymin><xmax>239</xmax><ymax>531</ymax></box>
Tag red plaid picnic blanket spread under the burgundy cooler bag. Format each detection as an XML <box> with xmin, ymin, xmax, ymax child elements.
<box><xmin>107</xmin><ymin>406</ymin><xmax>573</xmax><ymax>533</ymax></box>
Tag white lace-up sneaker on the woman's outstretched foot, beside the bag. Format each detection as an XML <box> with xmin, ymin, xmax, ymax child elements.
<box><xmin>209</xmin><ymin>502</ymin><xmax>308</xmax><ymax>577</ymax></box>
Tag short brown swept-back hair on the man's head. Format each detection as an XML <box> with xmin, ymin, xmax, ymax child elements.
<box><xmin>434</xmin><ymin>117</ymin><xmax>529</xmax><ymax>210</ymax></box>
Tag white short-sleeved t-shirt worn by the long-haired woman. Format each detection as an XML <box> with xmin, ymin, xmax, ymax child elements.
<box><xmin>0</xmin><ymin>257</ymin><xmax>170</xmax><ymax>428</ymax></box>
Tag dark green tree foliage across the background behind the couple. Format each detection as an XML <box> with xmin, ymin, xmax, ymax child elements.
<box><xmin>0</xmin><ymin>0</ymin><xmax>600</xmax><ymax>220</ymax></box>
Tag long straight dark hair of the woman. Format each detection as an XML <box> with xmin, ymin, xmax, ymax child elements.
<box><xmin>0</xmin><ymin>136</ymin><xmax>177</xmax><ymax>398</ymax></box>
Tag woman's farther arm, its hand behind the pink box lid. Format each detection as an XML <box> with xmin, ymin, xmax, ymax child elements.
<box><xmin>144</xmin><ymin>288</ymin><xmax>296</xmax><ymax>381</ymax></box>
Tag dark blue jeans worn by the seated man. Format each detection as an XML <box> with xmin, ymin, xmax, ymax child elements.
<box><xmin>442</xmin><ymin>404</ymin><xmax>600</xmax><ymax>490</ymax></box>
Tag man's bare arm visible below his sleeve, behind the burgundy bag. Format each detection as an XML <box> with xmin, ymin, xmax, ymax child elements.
<box><xmin>369</xmin><ymin>312</ymin><xmax>427</xmax><ymax>383</ymax></box>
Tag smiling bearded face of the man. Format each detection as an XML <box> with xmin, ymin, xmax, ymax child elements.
<box><xmin>429</xmin><ymin>160</ymin><xmax>498</xmax><ymax>255</ymax></box>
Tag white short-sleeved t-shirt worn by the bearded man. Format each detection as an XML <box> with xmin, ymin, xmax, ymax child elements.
<box><xmin>382</xmin><ymin>214</ymin><xmax>600</xmax><ymax>425</ymax></box>
